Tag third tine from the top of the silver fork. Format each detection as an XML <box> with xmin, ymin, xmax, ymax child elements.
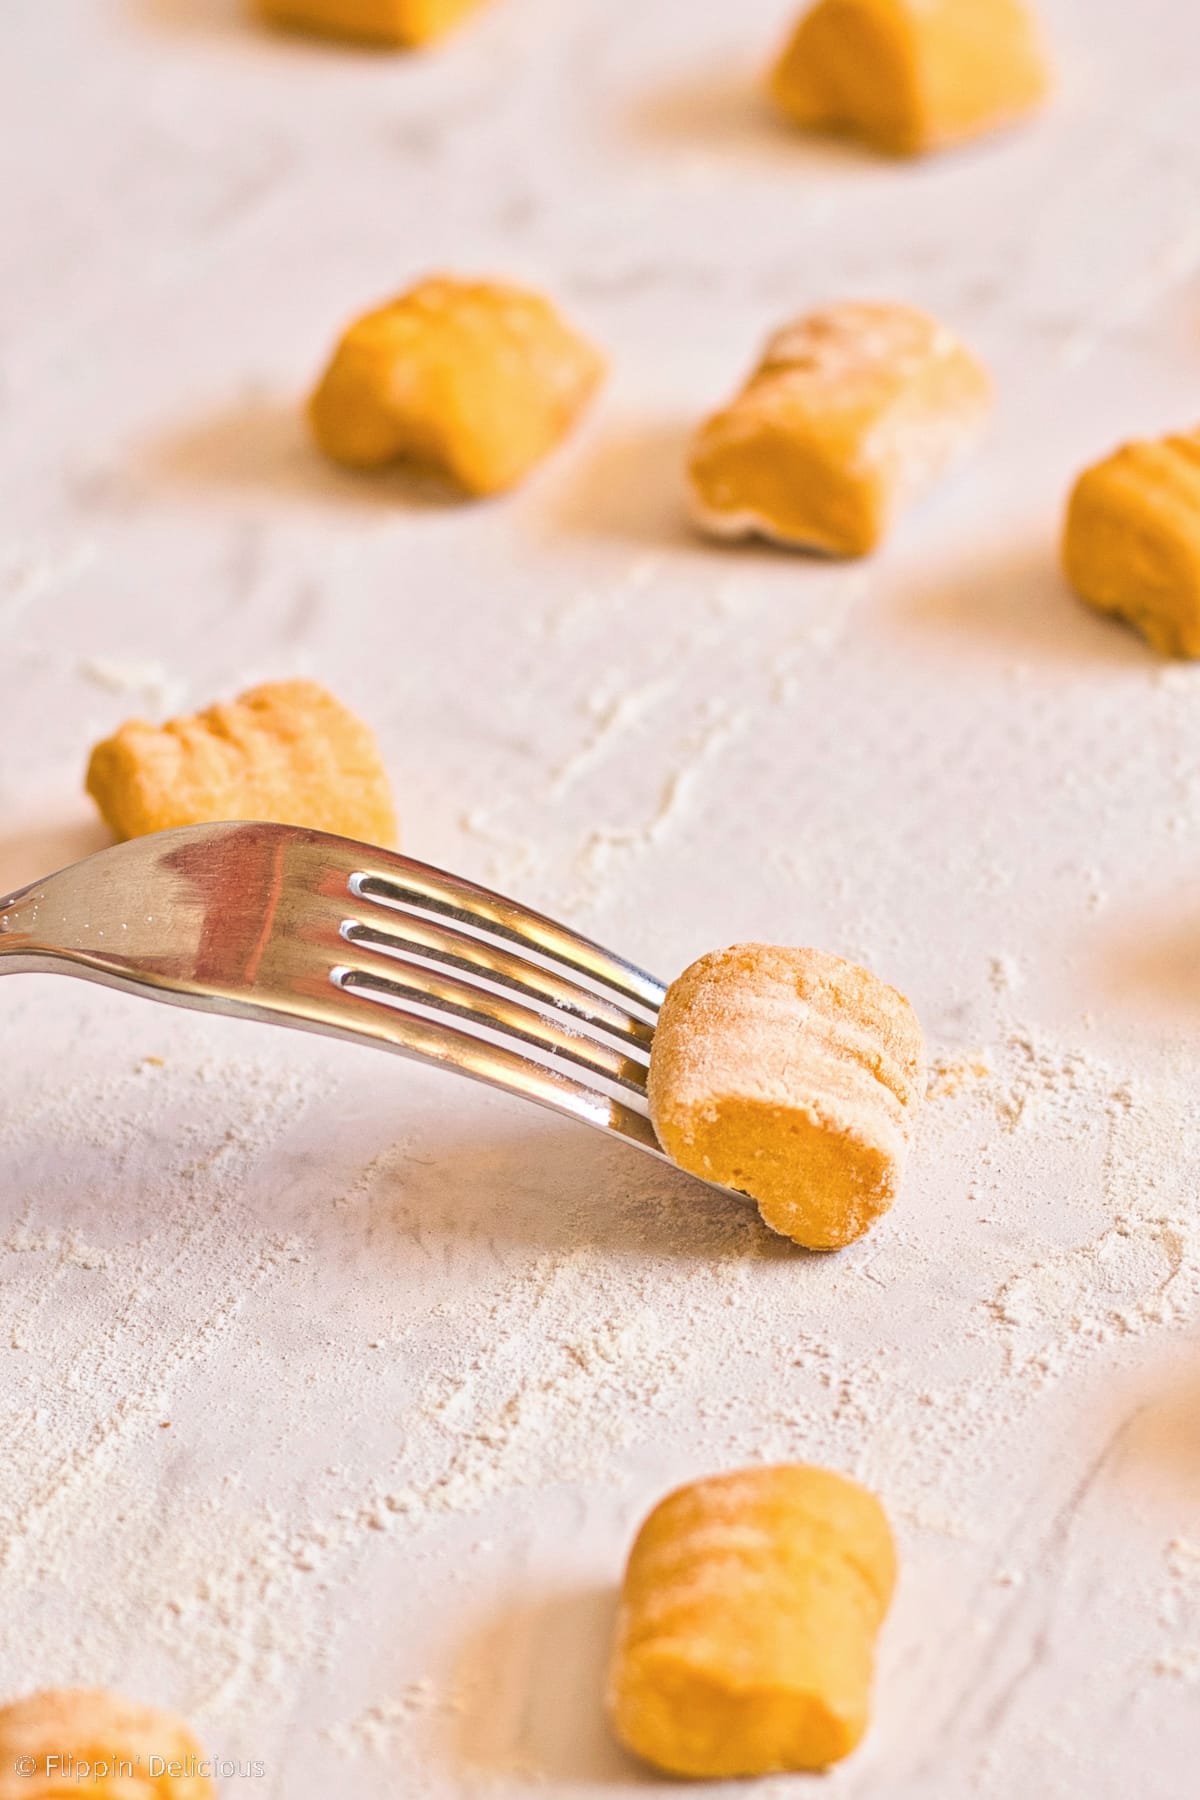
<box><xmin>331</xmin><ymin>956</ymin><xmax>646</xmax><ymax>1102</ymax></box>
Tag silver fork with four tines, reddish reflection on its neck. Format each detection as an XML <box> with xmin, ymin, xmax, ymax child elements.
<box><xmin>0</xmin><ymin>824</ymin><xmax>694</xmax><ymax>1180</ymax></box>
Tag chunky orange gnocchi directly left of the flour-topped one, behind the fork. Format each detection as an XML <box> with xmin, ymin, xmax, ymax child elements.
<box><xmin>309</xmin><ymin>277</ymin><xmax>604</xmax><ymax>495</ymax></box>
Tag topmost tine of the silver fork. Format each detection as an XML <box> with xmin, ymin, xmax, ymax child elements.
<box><xmin>351</xmin><ymin>851</ymin><xmax>666</xmax><ymax>1017</ymax></box>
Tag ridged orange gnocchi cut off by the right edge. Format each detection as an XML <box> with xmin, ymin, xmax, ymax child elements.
<box><xmin>1063</xmin><ymin>432</ymin><xmax>1200</xmax><ymax>657</ymax></box>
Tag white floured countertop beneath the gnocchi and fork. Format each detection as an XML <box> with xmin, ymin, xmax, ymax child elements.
<box><xmin>0</xmin><ymin>0</ymin><xmax>1200</xmax><ymax>1800</ymax></box>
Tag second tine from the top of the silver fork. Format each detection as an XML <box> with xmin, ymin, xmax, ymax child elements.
<box><xmin>342</xmin><ymin>913</ymin><xmax>655</xmax><ymax>1055</ymax></box>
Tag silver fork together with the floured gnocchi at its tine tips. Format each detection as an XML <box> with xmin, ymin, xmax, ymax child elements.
<box><xmin>0</xmin><ymin>823</ymin><xmax>925</xmax><ymax>1249</ymax></box>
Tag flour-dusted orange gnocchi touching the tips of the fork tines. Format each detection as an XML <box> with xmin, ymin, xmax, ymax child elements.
<box><xmin>648</xmin><ymin>943</ymin><xmax>927</xmax><ymax>1249</ymax></box>
